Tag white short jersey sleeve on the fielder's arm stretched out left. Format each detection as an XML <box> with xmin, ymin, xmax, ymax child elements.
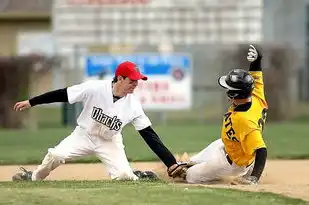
<box><xmin>67</xmin><ymin>81</ymin><xmax>92</xmax><ymax>104</ymax></box>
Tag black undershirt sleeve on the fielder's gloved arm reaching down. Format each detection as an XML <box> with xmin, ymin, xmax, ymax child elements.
<box><xmin>138</xmin><ymin>126</ymin><xmax>176</xmax><ymax>167</ymax></box>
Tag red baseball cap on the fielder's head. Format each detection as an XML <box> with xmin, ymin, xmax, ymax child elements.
<box><xmin>115</xmin><ymin>61</ymin><xmax>148</xmax><ymax>80</ymax></box>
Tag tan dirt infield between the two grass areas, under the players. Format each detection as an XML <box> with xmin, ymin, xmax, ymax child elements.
<box><xmin>0</xmin><ymin>160</ymin><xmax>309</xmax><ymax>201</ymax></box>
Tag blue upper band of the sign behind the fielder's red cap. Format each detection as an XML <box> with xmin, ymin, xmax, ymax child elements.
<box><xmin>85</xmin><ymin>54</ymin><xmax>192</xmax><ymax>77</ymax></box>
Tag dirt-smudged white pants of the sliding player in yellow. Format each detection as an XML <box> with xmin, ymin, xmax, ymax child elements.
<box><xmin>186</xmin><ymin>139</ymin><xmax>253</xmax><ymax>183</ymax></box>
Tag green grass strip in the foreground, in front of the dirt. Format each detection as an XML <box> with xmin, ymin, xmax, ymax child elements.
<box><xmin>0</xmin><ymin>181</ymin><xmax>308</xmax><ymax>205</ymax></box>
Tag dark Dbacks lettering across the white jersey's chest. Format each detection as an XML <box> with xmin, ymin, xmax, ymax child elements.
<box><xmin>91</xmin><ymin>107</ymin><xmax>122</xmax><ymax>131</ymax></box>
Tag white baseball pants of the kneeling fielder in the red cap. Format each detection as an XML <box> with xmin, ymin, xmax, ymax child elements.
<box><xmin>32</xmin><ymin>126</ymin><xmax>138</xmax><ymax>181</ymax></box>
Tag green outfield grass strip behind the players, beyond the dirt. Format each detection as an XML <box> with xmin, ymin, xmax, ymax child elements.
<box><xmin>0</xmin><ymin>123</ymin><xmax>309</xmax><ymax>164</ymax></box>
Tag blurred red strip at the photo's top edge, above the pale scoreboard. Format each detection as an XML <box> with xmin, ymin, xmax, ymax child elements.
<box><xmin>67</xmin><ymin>0</ymin><xmax>151</xmax><ymax>5</ymax></box>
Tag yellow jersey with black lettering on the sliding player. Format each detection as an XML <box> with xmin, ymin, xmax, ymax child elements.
<box><xmin>221</xmin><ymin>71</ymin><xmax>268</xmax><ymax>166</ymax></box>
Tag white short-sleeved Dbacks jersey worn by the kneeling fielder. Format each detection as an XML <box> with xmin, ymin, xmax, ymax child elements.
<box><xmin>67</xmin><ymin>80</ymin><xmax>151</xmax><ymax>139</ymax></box>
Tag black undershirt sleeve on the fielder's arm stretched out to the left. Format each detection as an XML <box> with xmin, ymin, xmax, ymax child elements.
<box><xmin>29</xmin><ymin>88</ymin><xmax>68</xmax><ymax>107</ymax></box>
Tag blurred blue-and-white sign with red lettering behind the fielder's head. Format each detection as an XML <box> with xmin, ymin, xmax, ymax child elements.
<box><xmin>85</xmin><ymin>53</ymin><xmax>192</xmax><ymax>110</ymax></box>
